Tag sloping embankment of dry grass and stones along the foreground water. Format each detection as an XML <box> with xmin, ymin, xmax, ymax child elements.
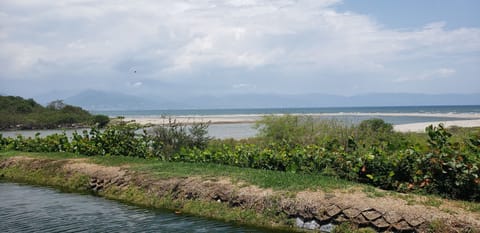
<box><xmin>0</xmin><ymin>156</ymin><xmax>480</xmax><ymax>232</ymax></box>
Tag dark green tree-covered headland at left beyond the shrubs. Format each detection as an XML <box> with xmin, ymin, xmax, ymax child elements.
<box><xmin>0</xmin><ymin>96</ymin><xmax>109</xmax><ymax>130</ymax></box>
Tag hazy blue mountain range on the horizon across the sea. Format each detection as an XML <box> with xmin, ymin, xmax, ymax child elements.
<box><xmin>59</xmin><ymin>90</ymin><xmax>480</xmax><ymax>110</ymax></box>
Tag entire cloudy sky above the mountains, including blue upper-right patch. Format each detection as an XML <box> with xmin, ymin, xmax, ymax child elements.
<box><xmin>0</xmin><ymin>0</ymin><xmax>480</xmax><ymax>97</ymax></box>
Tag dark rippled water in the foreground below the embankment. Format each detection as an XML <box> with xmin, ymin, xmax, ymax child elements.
<box><xmin>0</xmin><ymin>182</ymin><xmax>266</xmax><ymax>232</ymax></box>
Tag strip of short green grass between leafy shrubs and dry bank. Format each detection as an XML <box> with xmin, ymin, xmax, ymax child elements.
<box><xmin>0</xmin><ymin>151</ymin><xmax>352</xmax><ymax>191</ymax></box>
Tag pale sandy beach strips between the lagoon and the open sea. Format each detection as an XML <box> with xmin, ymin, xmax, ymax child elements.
<box><xmin>124</xmin><ymin>113</ymin><xmax>480</xmax><ymax>132</ymax></box>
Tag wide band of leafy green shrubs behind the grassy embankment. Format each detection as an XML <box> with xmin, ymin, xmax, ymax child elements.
<box><xmin>0</xmin><ymin>115</ymin><xmax>480</xmax><ymax>201</ymax></box>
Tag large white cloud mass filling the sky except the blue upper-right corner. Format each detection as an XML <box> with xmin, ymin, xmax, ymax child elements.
<box><xmin>0</xmin><ymin>0</ymin><xmax>480</xmax><ymax>95</ymax></box>
